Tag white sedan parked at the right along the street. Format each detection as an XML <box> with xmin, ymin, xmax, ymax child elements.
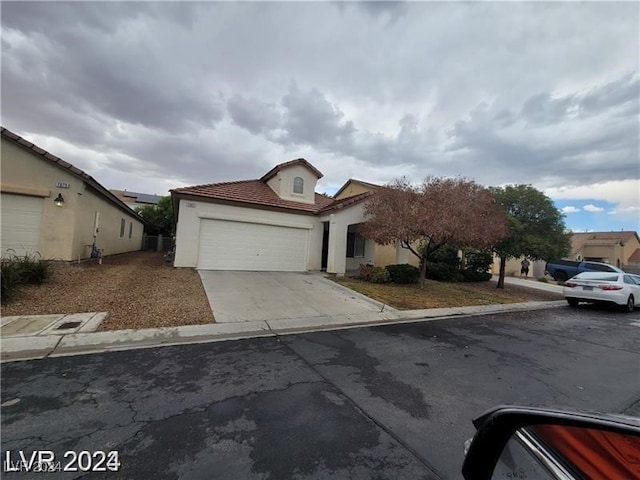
<box><xmin>563</xmin><ymin>272</ymin><xmax>640</xmax><ymax>312</ymax></box>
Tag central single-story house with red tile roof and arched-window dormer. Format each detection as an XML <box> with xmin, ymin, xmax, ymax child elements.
<box><xmin>171</xmin><ymin>158</ymin><xmax>417</xmax><ymax>275</ymax></box>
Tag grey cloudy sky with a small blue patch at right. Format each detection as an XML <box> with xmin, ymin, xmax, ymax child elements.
<box><xmin>0</xmin><ymin>1</ymin><xmax>640</xmax><ymax>231</ymax></box>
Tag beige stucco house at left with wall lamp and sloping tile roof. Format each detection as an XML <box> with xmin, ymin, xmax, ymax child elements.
<box><xmin>0</xmin><ymin>128</ymin><xmax>144</xmax><ymax>261</ymax></box>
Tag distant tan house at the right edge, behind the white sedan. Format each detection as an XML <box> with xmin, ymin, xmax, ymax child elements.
<box><xmin>571</xmin><ymin>231</ymin><xmax>640</xmax><ymax>269</ymax></box>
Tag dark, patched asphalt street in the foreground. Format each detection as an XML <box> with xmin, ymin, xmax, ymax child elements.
<box><xmin>1</xmin><ymin>306</ymin><xmax>640</xmax><ymax>479</ymax></box>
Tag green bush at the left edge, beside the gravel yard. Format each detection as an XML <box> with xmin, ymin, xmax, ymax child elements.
<box><xmin>0</xmin><ymin>254</ymin><xmax>51</xmax><ymax>303</ymax></box>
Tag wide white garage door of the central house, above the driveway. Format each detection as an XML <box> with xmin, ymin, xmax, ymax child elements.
<box><xmin>198</xmin><ymin>220</ymin><xmax>309</xmax><ymax>272</ymax></box>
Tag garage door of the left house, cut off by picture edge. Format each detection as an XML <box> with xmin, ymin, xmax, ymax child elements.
<box><xmin>0</xmin><ymin>193</ymin><xmax>44</xmax><ymax>257</ymax></box>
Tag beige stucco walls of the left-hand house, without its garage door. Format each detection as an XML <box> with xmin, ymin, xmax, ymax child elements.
<box><xmin>0</xmin><ymin>138</ymin><xmax>143</xmax><ymax>260</ymax></box>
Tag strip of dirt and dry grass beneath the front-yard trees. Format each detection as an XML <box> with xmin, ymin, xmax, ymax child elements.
<box><xmin>334</xmin><ymin>278</ymin><xmax>563</xmax><ymax>310</ymax></box>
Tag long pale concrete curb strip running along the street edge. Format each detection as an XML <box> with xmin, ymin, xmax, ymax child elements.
<box><xmin>1</xmin><ymin>300</ymin><xmax>566</xmax><ymax>363</ymax></box>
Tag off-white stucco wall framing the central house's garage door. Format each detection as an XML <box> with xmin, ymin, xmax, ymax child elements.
<box><xmin>174</xmin><ymin>199</ymin><xmax>323</xmax><ymax>270</ymax></box>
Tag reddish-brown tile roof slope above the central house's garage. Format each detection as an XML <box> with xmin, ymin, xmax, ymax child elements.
<box><xmin>171</xmin><ymin>177</ymin><xmax>334</xmax><ymax>213</ymax></box>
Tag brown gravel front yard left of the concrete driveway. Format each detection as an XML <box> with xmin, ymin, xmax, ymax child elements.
<box><xmin>2</xmin><ymin>252</ymin><xmax>214</xmax><ymax>330</ymax></box>
